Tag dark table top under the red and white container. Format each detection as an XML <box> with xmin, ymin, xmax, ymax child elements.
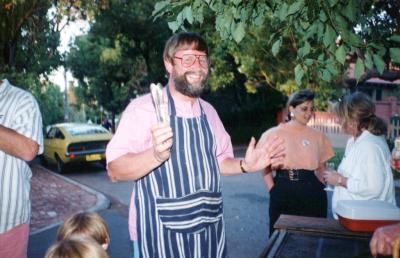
<box><xmin>260</xmin><ymin>215</ymin><xmax>382</xmax><ymax>258</ymax></box>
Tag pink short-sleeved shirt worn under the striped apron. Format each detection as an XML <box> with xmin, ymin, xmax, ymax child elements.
<box><xmin>106</xmin><ymin>87</ymin><xmax>234</xmax><ymax>240</ymax></box>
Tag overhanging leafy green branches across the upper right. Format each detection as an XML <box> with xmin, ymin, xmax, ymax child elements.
<box><xmin>153</xmin><ymin>0</ymin><xmax>400</xmax><ymax>85</ymax></box>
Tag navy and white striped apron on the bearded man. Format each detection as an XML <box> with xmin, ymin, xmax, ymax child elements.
<box><xmin>135</xmin><ymin>88</ymin><xmax>226</xmax><ymax>258</ymax></box>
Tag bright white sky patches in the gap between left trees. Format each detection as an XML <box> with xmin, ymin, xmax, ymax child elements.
<box><xmin>49</xmin><ymin>20</ymin><xmax>89</xmax><ymax>91</ymax></box>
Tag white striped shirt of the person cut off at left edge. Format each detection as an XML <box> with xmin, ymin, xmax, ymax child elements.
<box><xmin>0</xmin><ymin>80</ymin><xmax>43</xmax><ymax>233</ymax></box>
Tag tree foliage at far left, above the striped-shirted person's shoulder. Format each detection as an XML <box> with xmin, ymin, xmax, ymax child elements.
<box><xmin>0</xmin><ymin>0</ymin><xmax>106</xmax><ymax>125</ymax></box>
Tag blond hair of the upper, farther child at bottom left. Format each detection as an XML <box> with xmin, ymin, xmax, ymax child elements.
<box><xmin>57</xmin><ymin>212</ymin><xmax>110</xmax><ymax>245</ymax></box>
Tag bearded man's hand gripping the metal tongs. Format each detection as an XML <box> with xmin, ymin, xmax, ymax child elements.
<box><xmin>151</xmin><ymin>123</ymin><xmax>173</xmax><ymax>163</ymax></box>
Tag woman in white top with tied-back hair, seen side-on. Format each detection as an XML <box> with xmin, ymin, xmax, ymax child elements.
<box><xmin>324</xmin><ymin>92</ymin><xmax>396</xmax><ymax>218</ymax></box>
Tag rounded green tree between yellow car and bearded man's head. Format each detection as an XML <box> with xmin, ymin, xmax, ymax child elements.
<box><xmin>67</xmin><ymin>1</ymin><xmax>171</xmax><ymax>127</ymax></box>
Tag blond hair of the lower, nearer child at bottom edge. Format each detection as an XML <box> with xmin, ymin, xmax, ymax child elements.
<box><xmin>45</xmin><ymin>237</ymin><xmax>109</xmax><ymax>258</ymax></box>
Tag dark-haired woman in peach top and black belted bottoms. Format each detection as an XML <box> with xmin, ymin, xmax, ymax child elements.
<box><xmin>259</xmin><ymin>90</ymin><xmax>334</xmax><ymax>235</ymax></box>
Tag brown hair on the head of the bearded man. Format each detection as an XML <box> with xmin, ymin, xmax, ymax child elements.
<box><xmin>163</xmin><ymin>32</ymin><xmax>208</xmax><ymax>63</ymax></box>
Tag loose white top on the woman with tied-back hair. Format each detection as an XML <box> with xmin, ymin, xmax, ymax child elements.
<box><xmin>332</xmin><ymin>130</ymin><xmax>396</xmax><ymax>219</ymax></box>
